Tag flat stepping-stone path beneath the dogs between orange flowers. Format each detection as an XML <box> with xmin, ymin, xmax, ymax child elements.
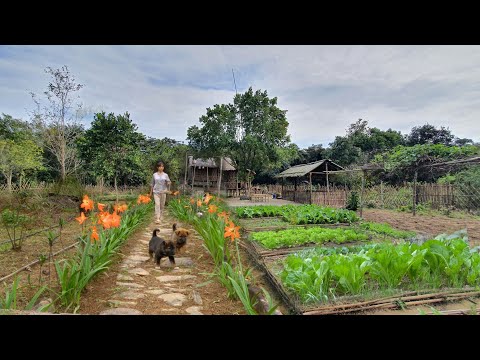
<box><xmin>100</xmin><ymin>216</ymin><xmax>203</xmax><ymax>315</ymax></box>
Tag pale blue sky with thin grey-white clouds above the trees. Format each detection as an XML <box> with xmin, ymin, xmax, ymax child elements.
<box><xmin>0</xmin><ymin>45</ymin><xmax>480</xmax><ymax>148</ymax></box>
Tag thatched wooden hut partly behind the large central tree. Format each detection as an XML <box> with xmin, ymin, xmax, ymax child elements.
<box><xmin>187</xmin><ymin>156</ymin><xmax>237</xmax><ymax>190</ymax></box>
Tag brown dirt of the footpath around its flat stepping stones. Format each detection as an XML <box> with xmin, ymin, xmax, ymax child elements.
<box><xmin>78</xmin><ymin>211</ymin><xmax>245</xmax><ymax>315</ymax></box>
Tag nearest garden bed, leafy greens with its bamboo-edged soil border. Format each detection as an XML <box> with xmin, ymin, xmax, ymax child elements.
<box><xmin>248</xmin><ymin>231</ymin><xmax>480</xmax><ymax>315</ymax></box>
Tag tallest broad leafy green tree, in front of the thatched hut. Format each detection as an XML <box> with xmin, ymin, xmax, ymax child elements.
<box><xmin>187</xmin><ymin>87</ymin><xmax>290</xmax><ymax>178</ymax></box>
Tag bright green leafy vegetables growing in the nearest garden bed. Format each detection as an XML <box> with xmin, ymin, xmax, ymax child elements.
<box><xmin>280</xmin><ymin>232</ymin><xmax>480</xmax><ymax>303</ymax></box>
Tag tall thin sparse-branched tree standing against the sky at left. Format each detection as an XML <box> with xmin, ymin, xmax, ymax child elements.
<box><xmin>30</xmin><ymin>65</ymin><xmax>83</xmax><ymax>181</ymax></box>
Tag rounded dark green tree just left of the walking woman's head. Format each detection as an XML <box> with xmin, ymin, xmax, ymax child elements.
<box><xmin>77</xmin><ymin>112</ymin><xmax>145</xmax><ymax>190</ymax></box>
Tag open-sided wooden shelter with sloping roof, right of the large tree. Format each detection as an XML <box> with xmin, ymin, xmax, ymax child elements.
<box><xmin>275</xmin><ymin>159</ymin><xmax>344</xmax><ymax>203</ymax></box>
